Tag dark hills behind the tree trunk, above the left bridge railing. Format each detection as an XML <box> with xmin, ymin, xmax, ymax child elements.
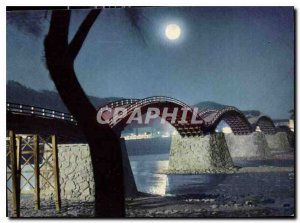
<box><xmin>6</xmin><ymin>81</ymin><xmax>122</xmax><ymax>112</ymax></box>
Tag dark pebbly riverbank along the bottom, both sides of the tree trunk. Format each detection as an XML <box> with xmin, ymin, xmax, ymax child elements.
<box><xmin>8</xmin><ymin>188</ymin><xmax>294</xmax><ymax>218</ymax></box>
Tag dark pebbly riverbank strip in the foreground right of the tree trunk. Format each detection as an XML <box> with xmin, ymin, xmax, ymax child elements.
<box><xmin>126</xmin><ymin>194</ymin><xmax>294</xmax><ymax>218</ymax></box>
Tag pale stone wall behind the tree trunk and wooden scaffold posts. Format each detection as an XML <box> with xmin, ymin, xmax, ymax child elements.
<box><xmin>41</xmin><ymin>140</ymin><xmax>137</xmax><ymax>201</ymax></box>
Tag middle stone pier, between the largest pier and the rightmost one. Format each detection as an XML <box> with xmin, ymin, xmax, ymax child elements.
<box><xmin>225</xmin><ymin>132</ymin><xmax>270</xmax><ymax>160</ymax></box>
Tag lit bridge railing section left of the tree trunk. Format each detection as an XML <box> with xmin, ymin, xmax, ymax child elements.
<box><xmin>6</xmin><ymin>103</ymin><xmax>77</xmax><ymax>124</ymax></box>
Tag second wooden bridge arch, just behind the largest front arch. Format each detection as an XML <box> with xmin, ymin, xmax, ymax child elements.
<box><xmin>200</xmin><ymin>107</ymin><xmax>252</xmax><ymax>135</ymax></box>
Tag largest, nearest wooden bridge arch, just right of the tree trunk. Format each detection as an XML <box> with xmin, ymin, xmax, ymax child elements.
<box><xmin>100</xmin><ymin>96</ymin><xmax>204</xmax><ymax>136</ymax></box>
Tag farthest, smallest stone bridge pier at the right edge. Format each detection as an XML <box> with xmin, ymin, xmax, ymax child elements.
<box><xmin>266</xmin><ymin>132</ymin><xmax>291</xmax><ymax>151</ymax></box>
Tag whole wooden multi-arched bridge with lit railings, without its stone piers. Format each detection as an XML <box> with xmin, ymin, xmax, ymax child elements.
<box><xmin>6</xmin><ymin>96</ymin><xmax>276</xmax><ymax>136</ymax></box>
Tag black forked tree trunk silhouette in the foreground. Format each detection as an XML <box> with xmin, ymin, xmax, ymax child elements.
<box><xmin>44</xmin><ymin>9</ymin><xmax>125</xmax><ymax>217</ymax></box>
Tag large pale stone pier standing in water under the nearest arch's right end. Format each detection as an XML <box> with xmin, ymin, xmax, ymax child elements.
<box><xmin>168</xmin><ymin>133</ymin><xmax>234</xmax><ymax>174</ymax></box>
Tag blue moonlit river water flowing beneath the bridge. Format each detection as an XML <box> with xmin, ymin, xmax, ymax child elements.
<box><xmin>129</xmin><ymin>154</ymin><xmax>294</xmax><ymax>206</ymax></box>
